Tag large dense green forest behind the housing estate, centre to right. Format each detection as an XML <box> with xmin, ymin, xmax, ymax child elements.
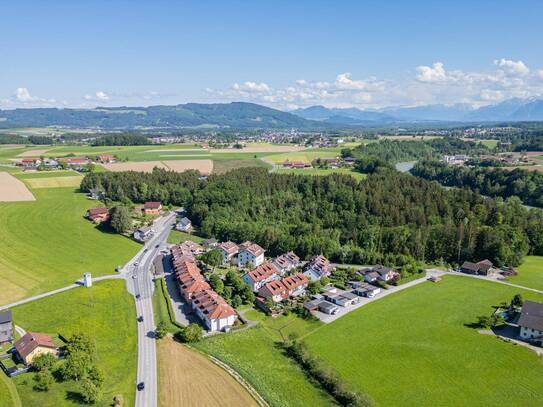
<box><xmin>81</xmin><ymin>168</ymin><xmax>543</xmax><ymax>266</ymax></box>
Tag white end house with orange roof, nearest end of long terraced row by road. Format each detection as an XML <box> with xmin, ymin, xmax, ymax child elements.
<box><xmin>192</xmin><ymin>290</ymin><xmax>237</xmax><ymax>332</ymax></box>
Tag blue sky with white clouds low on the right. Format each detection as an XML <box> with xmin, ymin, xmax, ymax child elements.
<box><xmin>0</xmin><ymin>0</ymin><xmax>543</xmax><ymax>109</ymax></box>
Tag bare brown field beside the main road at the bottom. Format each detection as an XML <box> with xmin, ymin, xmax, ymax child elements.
<box><xmin>158</xmin><ymin>338</ymin><xmax>258</xmax><ymax>407</ymax></box>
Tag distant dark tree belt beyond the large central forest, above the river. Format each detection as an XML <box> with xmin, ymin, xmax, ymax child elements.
<box><xmin>348</xmin><ymin>137</ymin><xmax>490</xmax><ymax>164</ymax></box>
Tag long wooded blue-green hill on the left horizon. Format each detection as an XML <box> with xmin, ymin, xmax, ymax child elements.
<box><xmin>0</xmin><ymin>102</ymin><xmax>318</xmax><ymax>129</ymax></box>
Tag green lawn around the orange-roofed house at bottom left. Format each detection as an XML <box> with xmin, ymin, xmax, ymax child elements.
<box><xmin>13</xmin><ymin>281</ymin><xmax>137</xmax><ymax>407</ymax></box>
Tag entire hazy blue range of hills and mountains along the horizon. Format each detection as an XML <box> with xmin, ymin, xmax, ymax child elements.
<box><xmin>0</xmin><ymin>99</ymin><xmax>543</xmax><ymax>129</ymax></box>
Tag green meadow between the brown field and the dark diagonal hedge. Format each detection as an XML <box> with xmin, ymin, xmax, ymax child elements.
<box><xmin>196</xmin><ymin>311</ymin><xmax>334</xmax><ymax>407</ymax></box>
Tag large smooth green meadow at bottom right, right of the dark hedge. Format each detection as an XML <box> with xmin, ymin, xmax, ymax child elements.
<box><xmin>305</xmin><ymin>276</ymin><xmax>543</xmax><ymax>406</ymax></box>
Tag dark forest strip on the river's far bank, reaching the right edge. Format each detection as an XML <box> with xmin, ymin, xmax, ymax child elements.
<box><xmin>411</xmin><ymin>161</ymin><xmax>543</xmax><ymax>207</ymax></box>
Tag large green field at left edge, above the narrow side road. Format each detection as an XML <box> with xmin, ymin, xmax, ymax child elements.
<box><xmin>0</xmin><ymin>188</ymin><xmax>140</xmax><ymax>304</ymax></box>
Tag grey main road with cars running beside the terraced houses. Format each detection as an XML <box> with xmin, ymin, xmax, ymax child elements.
<box><xmin>127</xmin><ymin>214</ymin><xmax>175</xmax><ymax>407</ymax></box>
